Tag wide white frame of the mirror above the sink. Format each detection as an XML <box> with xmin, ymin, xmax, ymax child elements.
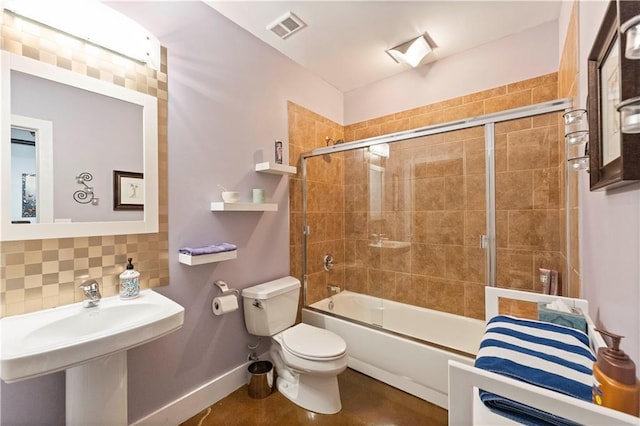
<box><xmin>0</xmin><ymin>51</ymin><xmax>159</xmax><ymax>241</ymax></box>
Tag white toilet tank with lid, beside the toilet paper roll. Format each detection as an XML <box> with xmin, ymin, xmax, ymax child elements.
<box><xmin>242</xmin><ymin>277</ymin><xmax>300</xmax><ymax>336</ymax></box>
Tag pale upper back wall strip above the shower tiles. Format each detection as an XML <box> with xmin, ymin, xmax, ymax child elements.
<box><xmin>344</xmin><ymin>22</ymin><xmax>558</xmax><ymax>124</ymax></box>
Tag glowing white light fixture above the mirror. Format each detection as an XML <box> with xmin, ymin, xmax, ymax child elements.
<box><xmin>3</xmin><ymin>0</ymin><xmax>160</xmax><ymax>69</ymax></box>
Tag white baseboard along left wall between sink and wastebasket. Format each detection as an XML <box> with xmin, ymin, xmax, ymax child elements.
<box><xmin>132</xmin><ymin>362</ymin><xmax>249</xmax><ymax>426</ymax></box>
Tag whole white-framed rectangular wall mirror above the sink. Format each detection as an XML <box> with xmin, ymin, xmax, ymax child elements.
<box><xmin>0</xmin><ymin>51</ymin><xmax>158</xmax><ymax>241</ymax></box>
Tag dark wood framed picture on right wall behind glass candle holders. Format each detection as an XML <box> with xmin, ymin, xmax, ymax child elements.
<box><xmin>587</xmin><ymin>0</ymin><xmax>640</xmax><ymax>191</ymax></box>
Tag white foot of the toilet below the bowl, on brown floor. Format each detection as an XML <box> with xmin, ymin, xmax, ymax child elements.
<box><xmin>276</xmin><ymin>374</ymin><xmax>342</xmax><ymax>414</ymax></box>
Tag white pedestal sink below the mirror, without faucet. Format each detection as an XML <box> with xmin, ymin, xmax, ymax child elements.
<box><xmin>0</xmin><ymin>290</ymin><xmax>184</xmax><ymax>426</ymax></box>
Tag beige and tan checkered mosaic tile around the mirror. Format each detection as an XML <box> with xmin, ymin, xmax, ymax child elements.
<box><xmin>0</xmin><ymin>11</ymin><xmax>169</xmax><ymax>316</ymax></box>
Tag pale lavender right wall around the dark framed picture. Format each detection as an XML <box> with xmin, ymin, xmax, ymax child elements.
<box><xmin>579</xmin><ymin>1</ymin><xmax>640</xmax><ymax>366</ymax></box>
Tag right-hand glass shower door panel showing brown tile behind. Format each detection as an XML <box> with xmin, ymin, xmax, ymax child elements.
<box><xmin>495</xmin><ymin>113</ymin><xmax>564</xmax><ymax>292</ymax></box>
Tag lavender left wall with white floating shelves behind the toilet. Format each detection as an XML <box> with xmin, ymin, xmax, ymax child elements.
<box><xmin>1</xmin><ymin>2</ymin><xmax>343</xmax><ymax>425</ymax></box>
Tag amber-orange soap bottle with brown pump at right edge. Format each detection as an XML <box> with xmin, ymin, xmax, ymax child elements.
<box><xmin>593</xmin><ymin>329</ymin><xmax>640</xmax><ymax>416</ymax></box>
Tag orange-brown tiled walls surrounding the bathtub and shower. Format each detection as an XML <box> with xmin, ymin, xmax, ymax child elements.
<box><xmin>289</xmin><ymin>73</ymin><xmax>565</xmax><ymax>318</ymax></box>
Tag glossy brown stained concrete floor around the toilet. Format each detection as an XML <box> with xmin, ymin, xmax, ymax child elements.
<box><xmin>182</xmin><ymin>369</ymin><xmax>447</xmax><ymax>426</ymax></box>
